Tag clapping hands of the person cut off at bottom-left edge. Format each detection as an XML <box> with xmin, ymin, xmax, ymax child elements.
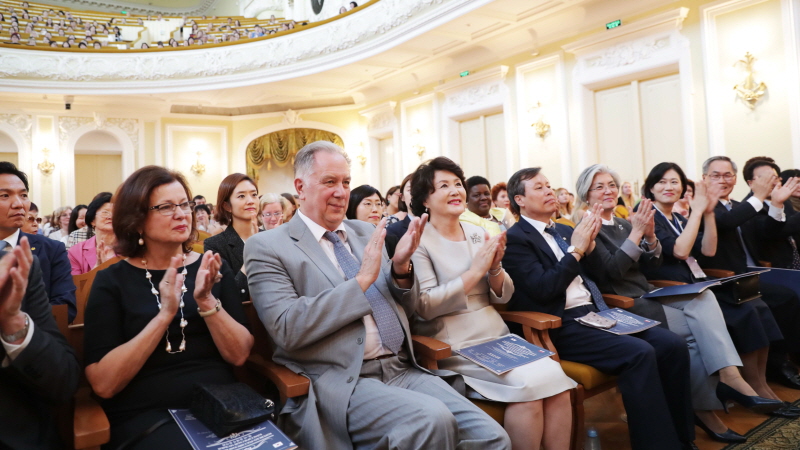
<box><xmin>0</xmin><ymin>237</ymin><xmax>33</xmax><ymax>334</ymax></box>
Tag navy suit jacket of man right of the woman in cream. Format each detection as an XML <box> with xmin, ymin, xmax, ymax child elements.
<box><xmin>503</xmin><ymin>218</ymin><xmax>602</xmax><ymax>317</ymax></box>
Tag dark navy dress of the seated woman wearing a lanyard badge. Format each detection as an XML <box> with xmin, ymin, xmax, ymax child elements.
<box><xmin>642</xmin><ymin>212</ymin><xmax>783</xmax><ymax>354</ymax></box>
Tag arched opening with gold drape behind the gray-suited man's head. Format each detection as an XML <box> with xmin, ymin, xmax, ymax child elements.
<box><xmin>246</xmin><ymin>128</ymin><xmax>344</xmax><ymax>193</ymax></box>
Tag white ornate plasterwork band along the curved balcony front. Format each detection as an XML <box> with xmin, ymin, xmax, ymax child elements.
<box><xmin>0</xmin><ymin>0</ymin><xmax>491</xmax><ymax>94</ymax></box>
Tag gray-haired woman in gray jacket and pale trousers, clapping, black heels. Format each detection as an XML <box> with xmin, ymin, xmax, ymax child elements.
<box><xmin>576</xmin><ymin>164</ymin><xmax>783</xmax><ymax>442</ymax></box>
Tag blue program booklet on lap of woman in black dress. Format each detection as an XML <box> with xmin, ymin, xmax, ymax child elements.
<box><xmin>169</xmin><ymin>409</ymin><xmax>297</xmax><ymax>450</ymax></box>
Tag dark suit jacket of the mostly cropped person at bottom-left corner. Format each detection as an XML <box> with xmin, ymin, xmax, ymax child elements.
<box><xmin>0</xmin><ymin>253</ymin><xmax>81</xmax><ymax>450</ymax></box>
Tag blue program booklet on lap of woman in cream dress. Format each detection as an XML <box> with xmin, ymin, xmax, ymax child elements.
<box><xmin>455</xmin><ymin>334</ymin><xmax>555</xmax><ymax>375</ymax></box>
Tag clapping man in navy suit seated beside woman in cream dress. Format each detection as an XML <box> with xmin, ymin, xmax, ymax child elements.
<box><xmin>503</xmin><ymin>168</ymin><xmax>696</xmax><ymax>450</ymax></box>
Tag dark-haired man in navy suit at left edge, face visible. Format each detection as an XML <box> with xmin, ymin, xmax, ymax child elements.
<box><xmin>0</xmin><ymin>161</ymin><xmax>78</xmax><ymax>322</ymax></box>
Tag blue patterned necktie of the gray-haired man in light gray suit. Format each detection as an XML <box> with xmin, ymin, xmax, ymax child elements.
<box><xmin>324</xmin><ymin>231</ymin><xmax>405</xmax><ymax>354</ymax></box>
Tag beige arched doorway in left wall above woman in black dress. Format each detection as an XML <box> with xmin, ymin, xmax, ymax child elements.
<box><xmin>75</xmin><ymin>130</ymin><xmax>122</xmax><ymax>204</ymax></box>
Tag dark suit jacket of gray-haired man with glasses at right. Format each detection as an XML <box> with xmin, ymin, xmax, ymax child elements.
<box><xmin>698</xmin><ymin>200</ymin><xmax>782</xmax><ymax>274</ymax></box>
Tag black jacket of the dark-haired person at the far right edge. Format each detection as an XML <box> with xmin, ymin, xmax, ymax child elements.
<box><xmin>742</xmin><ymin>194</ymin><xmax>800</xmax><ymax>269</ymax></box>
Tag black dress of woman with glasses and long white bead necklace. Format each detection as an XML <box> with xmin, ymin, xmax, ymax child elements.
<box><xmin>84</xmin><ymin>258</ymin><xmax>246</xmax><ymax>448</ymax></box>
